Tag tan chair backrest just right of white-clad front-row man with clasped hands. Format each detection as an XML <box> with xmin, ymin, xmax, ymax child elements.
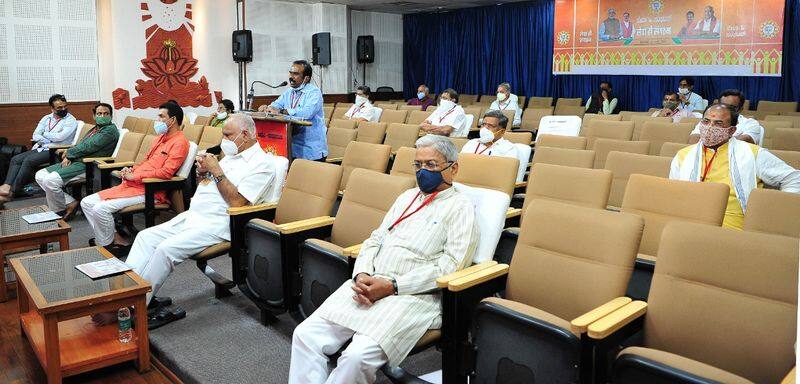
<box><xmin>275</xmin><ymin>159</ymin><xmax>342</xmax><ymax>224</ymax></box>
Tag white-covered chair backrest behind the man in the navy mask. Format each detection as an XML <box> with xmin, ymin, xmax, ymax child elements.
<box><xmin>453</xmin><ymin>183</ymin><xmax>511</xmax><ymax>264</ymax></box>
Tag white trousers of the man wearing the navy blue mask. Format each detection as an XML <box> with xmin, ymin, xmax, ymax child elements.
<box><xmin>289</xmin><ymin>315</ymin><xmax>388</xmax><ymax>384</ymax></box>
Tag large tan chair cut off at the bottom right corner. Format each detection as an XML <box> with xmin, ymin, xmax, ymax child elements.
<box><xmin>604</xmin><ymin>222</ymin><xmax>798</xmax><ymax>384</ymax></box>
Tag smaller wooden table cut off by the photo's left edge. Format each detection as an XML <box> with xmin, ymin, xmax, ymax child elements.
<box><xmin>0</xmin><ymin>205</ymin><xmax>72</xmax><ymax>303</ymax></box>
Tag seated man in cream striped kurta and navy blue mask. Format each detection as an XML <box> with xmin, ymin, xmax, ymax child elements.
<box><xmin>289</xmin><ymin>135</ymin><xmax>478</xmax><ymax>383</ymax></box>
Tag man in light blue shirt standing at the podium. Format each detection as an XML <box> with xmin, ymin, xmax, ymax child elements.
<box><xmin>258</xmin><ymin>60</ymin><xmax>328</xmax><ymax>161</ymax></box>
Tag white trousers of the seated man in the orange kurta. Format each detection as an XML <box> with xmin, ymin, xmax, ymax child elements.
<box><xmin>81</xmin><ymin>193</ymin><xmax>144</xmax><ymax>247</ymax></box>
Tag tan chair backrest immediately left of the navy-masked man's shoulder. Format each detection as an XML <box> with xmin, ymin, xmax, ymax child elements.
<box><xmin>331</xmin><ymin>168</ymin><xmax>416</xmax><ymax>248</ymax></box>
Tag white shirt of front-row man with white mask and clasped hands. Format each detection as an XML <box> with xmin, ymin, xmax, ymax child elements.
<box><xmin>176</xmin><ymin>143</ymin><xmax>275</xmax><ymax>240</ymax></box>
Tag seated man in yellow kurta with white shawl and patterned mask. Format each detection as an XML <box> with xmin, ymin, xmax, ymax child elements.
<box><xmin>669</xmin><ymin>104</ymin><xmax>800</xmax><ymax>229</ymax></box>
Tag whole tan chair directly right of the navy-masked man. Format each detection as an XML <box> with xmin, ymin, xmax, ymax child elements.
<box><xmin>450</xmin><ymin>200</ymin><xmax>643</xmax><ymax>383</ymax></box>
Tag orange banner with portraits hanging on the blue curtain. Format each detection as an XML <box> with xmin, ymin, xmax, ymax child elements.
<box><xmin>553</xmin><ymin>0</ymin><xmax>785</xmax><ymax>76</ymax></box>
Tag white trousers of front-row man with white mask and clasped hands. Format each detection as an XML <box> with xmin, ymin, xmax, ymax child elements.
<box><xmin>125</xmin><ymin>215</ymin><xmax>225</xmax><ymax>303</ymax></box>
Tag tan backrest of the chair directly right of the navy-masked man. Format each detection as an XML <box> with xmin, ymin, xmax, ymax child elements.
<box><xmin>505</xmin><ymin>200</ymin><xmax>643</xmax><ymax>320</ymax></box>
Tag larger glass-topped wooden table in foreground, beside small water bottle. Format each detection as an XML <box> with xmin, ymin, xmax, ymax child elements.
<box><xmin>11</xmin><ymin>247</ymin><xmax>150</xmax><ymax>383</ymax></box>
